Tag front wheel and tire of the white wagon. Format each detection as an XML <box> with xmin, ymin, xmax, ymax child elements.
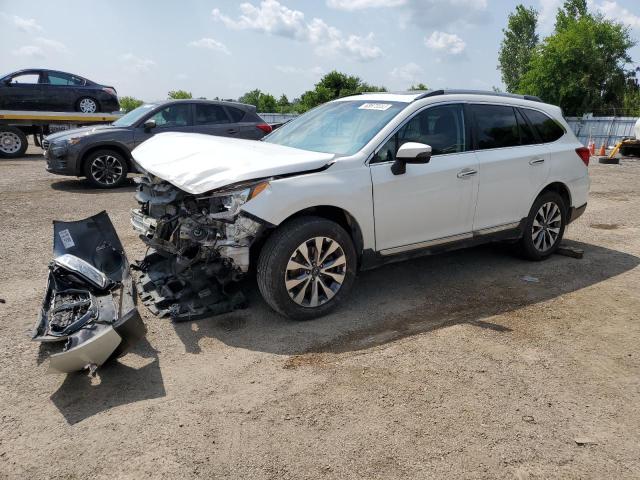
<box><xmin>256</xmin><ymin>216</ymin><xmax>357</xmax><ymax>320</ymax></box>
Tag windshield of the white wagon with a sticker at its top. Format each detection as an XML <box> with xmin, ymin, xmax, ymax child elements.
<box><xmin>263</xmin><ymin>100</ymin><xmax>407</xmax><ymax>155</ymax></box>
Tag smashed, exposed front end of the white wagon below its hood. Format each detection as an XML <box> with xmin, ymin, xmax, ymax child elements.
<box><xmin>131</xmin><ymin>175</ymin><xmax>269</xmax><ymax>321</ymax></box>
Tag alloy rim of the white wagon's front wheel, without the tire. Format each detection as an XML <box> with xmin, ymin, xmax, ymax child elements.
<box><xmin>284</xmin><ymin>237</ymin><xmax>347</xmax><ymax>308</ymax></box>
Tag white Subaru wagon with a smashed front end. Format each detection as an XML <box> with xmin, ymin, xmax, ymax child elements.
<box><xmin>132</xmin><ymin>90</ymin><xmax>589</xmax><ymax>320</ymax></box>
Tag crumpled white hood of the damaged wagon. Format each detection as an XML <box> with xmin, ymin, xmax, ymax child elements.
<box><xmin>132</xmin><ymin>132</ymin><xmax>335</xmax><ymax>195</ymax></box>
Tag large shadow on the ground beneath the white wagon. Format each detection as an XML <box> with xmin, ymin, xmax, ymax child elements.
<box><xmin>170</xmin><ymin>242</ymin><xmax>640</xmax><ymax>355</ymax></box>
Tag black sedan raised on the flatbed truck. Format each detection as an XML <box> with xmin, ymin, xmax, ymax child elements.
<box><xmin>0</xmin><ymin>69</ymin><xmax>120</xmax><ymax>113</ymax></box>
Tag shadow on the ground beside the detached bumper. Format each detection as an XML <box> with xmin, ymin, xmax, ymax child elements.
<box><xmin>50</xmin><ymin>339</ymin><xmax>166</xmax><ymax>425</ymax></box>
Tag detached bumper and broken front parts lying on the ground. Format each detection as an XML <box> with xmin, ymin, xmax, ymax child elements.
<box><xmin>32</xmin><ymin>212</ymin><xmax>146</xmax><ymax>373</ymax></box>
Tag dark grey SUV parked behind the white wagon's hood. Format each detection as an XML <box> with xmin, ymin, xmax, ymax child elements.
<box><xmin>42</xmin><ymin>100</ymin><xmax>271</xmax><ymax>188</ymax></box>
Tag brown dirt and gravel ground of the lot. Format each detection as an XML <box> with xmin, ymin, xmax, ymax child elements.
<box><xmin>0</xmin><ymin>150</ymin><xmax>640</xmax><ymax>479</ymax></box>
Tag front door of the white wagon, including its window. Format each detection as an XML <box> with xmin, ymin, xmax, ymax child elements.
<box><xmin>370</xmin><ymin>104</ymin><xmax>478</xmax><ymax>254</ymax></box>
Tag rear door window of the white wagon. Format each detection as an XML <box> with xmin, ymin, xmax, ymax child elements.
<box><xmin>471</xmin><ymin>105</ymin><xmax>520</xmax><ymax>150</ymax></box>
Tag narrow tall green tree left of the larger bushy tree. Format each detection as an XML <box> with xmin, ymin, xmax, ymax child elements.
<box><xmin>498</xmin><ymin>5</ymin><xmax>538</xmax><ymax>92</ymax></box>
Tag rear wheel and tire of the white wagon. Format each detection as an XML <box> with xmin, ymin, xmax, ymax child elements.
<box><xmin>520</xmin><ymin>192</ymin><xmax>568</xmax><ymax>261</ymax></box>
